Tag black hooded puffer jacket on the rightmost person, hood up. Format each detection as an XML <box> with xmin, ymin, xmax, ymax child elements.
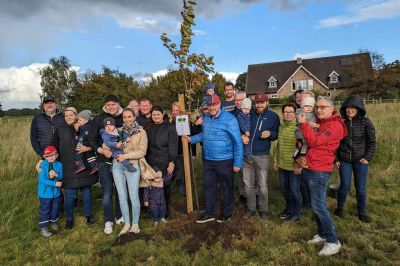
<box><xmin>337</xmin><ymin>95</ymin><xmax>376</xmax><ymax>162</ymax></box>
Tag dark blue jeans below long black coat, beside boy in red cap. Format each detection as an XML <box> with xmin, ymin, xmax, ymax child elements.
<box><xmin>64</xmin><ymin>186</ymin><xmax>92</xmax><ymax>220</ymax></box>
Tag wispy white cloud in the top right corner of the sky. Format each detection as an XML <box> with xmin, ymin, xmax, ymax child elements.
<box><xmin>317</xmin><ymin>0</ymin><xmax>400</xmax><ymax>28</ymax></box>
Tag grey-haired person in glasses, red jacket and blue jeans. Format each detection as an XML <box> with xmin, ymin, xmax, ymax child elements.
<box><xmin>298</xmin><ymin>97</ymin><xmax>347</xmax><ymax>256</ymax></box>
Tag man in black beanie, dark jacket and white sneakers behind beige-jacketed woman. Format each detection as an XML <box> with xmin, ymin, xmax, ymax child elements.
<box><xmin>89</xmin><ymin>94</ymin><xmax>123</xmax><ymax>235</ymax></box>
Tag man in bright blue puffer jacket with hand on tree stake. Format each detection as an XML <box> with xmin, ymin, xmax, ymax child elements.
<box><xmin>189</xmin><ymin>95</ymin><xmax>243</xmax><ymax>223</ymax></box>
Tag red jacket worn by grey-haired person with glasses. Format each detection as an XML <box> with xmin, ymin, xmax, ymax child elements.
<box><xmin>300</xmin><ymin>112</ymin><xmax>347</xmax><ymax>172</ymax></box>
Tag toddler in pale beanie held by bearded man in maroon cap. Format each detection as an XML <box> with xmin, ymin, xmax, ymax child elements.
<box><xmin>237</xmin><ymin>98</ymin><xmax>252</xmax><ymax>163</ymax></box>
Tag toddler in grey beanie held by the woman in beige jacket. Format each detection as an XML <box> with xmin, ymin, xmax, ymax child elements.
<box><xmin>100</xmin><ymin>117</ymin><xmax>136</xmax><ymax>172</ymax></box>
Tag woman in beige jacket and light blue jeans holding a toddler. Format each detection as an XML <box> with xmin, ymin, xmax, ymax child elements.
<box><xmin>112</xmin><ymin>108</ymin><xmax>147</xmax><ymax>235</ymax></box>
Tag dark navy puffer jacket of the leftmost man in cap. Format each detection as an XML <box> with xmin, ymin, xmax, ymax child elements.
<box><xmin>30</xmin><ymin>111</ymin><xmax>65</xmax><ymax>157</ymax></box>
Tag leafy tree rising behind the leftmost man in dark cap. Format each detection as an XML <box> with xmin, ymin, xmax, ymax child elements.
<box><xmin>40</xmin><ymin>56</ymin><xmax>79</xmax><ymax>107</ymax></box>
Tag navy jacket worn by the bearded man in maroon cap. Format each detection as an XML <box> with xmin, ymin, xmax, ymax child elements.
<box><xmin>249</xmin><ymin>109</ymin><xmax>280</xmax><ymax>156</ymax></box>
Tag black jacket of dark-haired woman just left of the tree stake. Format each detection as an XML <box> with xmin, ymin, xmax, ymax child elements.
<box><xmin>146</xmin><ymin>121</ymin><xmax>178</xmax><ymax>170</ymax></box>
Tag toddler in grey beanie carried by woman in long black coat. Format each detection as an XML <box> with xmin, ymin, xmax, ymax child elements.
<box><xmin>74</xmin><ymin>110</ymin><xmax>98</xmax><ymax>174</ymax></box>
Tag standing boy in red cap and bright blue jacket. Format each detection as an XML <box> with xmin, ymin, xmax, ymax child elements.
<box><xmin>38</xmin><ymin>146</ymin><xmax>62</xmax><ymax>238</ymax></box>
